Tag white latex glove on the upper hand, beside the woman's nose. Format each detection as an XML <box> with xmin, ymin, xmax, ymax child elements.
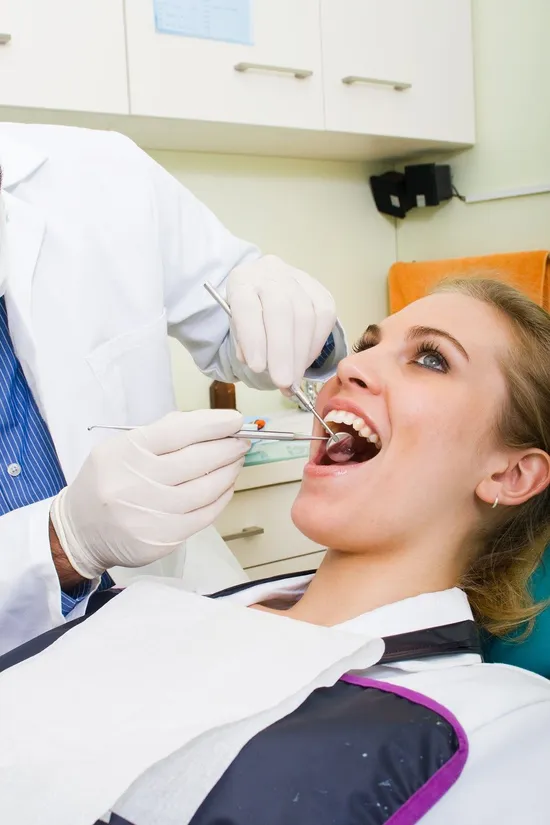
<box><xmin>226</xmin><ymin>255</ymin><xmax>336</xmax><ymax>388</ymax></box>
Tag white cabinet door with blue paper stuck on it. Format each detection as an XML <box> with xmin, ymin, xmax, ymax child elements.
<box><xmin>126</xmin><ymin>0</ymin><xmax>323</xmax><ymax>129</ymax></box>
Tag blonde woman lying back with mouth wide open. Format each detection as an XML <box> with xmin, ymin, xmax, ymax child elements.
<box><xmin>0</xmin><ymin>278</ymin><xmax>550</xmax><ymax>825</ymax></box>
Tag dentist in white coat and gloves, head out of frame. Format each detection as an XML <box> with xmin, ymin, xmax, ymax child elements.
<box><xmin>0</xmin><ymin>124</ymin><xmax>345</xmax><ymax>653</ymax></box>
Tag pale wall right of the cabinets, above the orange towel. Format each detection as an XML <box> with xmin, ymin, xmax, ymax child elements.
<box><xmin>397</xmin><ymin>0</ymin><xmax>550</xmax><ymax>260</ymax></box>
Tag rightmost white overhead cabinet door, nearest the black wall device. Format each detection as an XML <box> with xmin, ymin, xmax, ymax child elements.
<box><xmin>321</xmin><ymin>0</ymin><xmax>474</xmax><ymax>143</ymax></box>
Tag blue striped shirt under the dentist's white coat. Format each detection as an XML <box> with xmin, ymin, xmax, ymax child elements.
<box><xmin>0</xmin><ymin>297</ymin><xmax>113</xmax><ymax>616</ymax></box>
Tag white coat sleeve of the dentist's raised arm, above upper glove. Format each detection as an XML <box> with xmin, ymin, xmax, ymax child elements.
<box><xmin>144</xmin><ymin>148</ymin><xmax>346</xmax><ymax>389</ymax></box>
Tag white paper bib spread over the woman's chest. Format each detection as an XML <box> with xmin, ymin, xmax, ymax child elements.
<box><xmin>0</xmin><ymin>581</ymin><xmax>384</xmax><ymax>825</ymax></box>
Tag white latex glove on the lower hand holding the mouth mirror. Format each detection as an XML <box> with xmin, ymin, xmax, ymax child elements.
<box><xmin>51</xmin><ymin>410</ymin><xmax>250</xmax><ymax>579</ymax></box>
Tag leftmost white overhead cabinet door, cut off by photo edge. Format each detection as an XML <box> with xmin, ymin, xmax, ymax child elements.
<box><xmin>0</xmin><ymin>0</ymin><xmax>129</xmax><ymax>114</ymax></box>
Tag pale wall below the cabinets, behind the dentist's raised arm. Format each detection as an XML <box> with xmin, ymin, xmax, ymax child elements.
<box><xmin>148</xmin><ymin>152</ymin><xmax>395</xmax><ymax>414</ymax></box>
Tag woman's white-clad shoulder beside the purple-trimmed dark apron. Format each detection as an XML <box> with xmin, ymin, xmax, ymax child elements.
<box><xmin>408</xmin><ymin>663</ymin><xmax>550</xmax><ymax>825</ymax></box>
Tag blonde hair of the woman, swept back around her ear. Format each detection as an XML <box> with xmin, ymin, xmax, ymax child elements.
<box><xmin>433</xmin><ymin>272</ymin><xmax>550</xmax><ymax>638</ymax></box>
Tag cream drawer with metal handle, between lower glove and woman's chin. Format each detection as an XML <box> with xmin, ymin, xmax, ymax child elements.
<box><xmin>215</xmin><ymin>482</ymin><xmax>324</xmax><ymax>568</ymax></box>
